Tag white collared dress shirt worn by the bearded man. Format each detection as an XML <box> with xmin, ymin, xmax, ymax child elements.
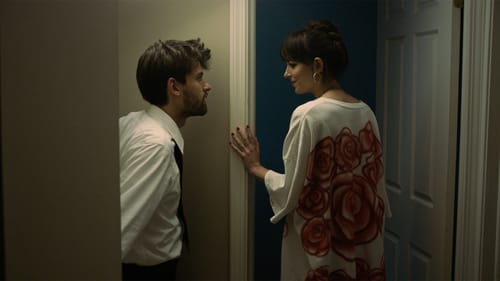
<box><xmin>119</xmin><ymin>105</ymin><xmax>184</xmax><ymax>265</ymax></box>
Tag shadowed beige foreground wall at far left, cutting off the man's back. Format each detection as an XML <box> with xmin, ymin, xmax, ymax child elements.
<box><xmin>0</xmin><ymin>0</ymin><xmax>120</xmax><ymax>280</ymax></box>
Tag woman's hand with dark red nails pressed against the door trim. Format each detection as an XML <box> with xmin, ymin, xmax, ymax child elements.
<box><xmin>229</xmin><ymin>126</ymin><xmax>267</xmax><ymax>180</ymax></box>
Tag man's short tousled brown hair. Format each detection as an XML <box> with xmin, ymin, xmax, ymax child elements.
<box><xmin>136</xmin><ymin>38</ymin><xmax>211</xmax><ymax>106</ymax></box>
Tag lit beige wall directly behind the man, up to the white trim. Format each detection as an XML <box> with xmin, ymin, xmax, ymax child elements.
<box><xmin>118</xmin><ymin>0</ymin><xmax>229</xmax><ymax>280</ymax></box>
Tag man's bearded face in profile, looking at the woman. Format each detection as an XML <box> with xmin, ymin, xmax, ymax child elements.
<box><xmin>183</xmin><ymin>64</ymin><xmax>212</xmax><ymax>117</ymax></box>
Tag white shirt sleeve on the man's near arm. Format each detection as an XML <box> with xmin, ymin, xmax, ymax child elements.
<box><xmin>120</xmin><ymin>143</ymin><xmax>178</xmax><ymax>258</ymax></box>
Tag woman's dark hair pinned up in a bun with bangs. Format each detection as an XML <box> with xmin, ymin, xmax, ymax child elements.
<box><xmin>280</xmin><ymin>20</ymin><xmax>349</xmax><ymax>78</ymax></box>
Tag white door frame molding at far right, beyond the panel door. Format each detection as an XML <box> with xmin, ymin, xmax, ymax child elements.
<box><xmin>455</xmin><ymin>0</ymin><xmax>494</xmax><ymax>280</ymax></box>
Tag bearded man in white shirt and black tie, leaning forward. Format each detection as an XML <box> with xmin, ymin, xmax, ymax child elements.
<box><xmin>119</xmin><ymin>39</ymin><xmax>211</xmax><ymax>280</ymax></box>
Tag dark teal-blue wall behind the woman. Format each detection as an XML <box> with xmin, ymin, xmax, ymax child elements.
<box><xmin>254</xmin><ymin>0</ymin><xmax>377</xmax><ymax>280</ymax></box>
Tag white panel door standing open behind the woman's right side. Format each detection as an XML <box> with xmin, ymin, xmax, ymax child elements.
<box><xmin>376</xmin><ymin>0</ymin><xmax>460</xmax><ymax>280</ymax></box>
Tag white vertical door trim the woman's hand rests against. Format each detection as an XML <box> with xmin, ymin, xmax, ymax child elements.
<box><xmin>229</xmin><ymin>0</ymin><xmax>255</xmax><ymax>280</ymax></box>
